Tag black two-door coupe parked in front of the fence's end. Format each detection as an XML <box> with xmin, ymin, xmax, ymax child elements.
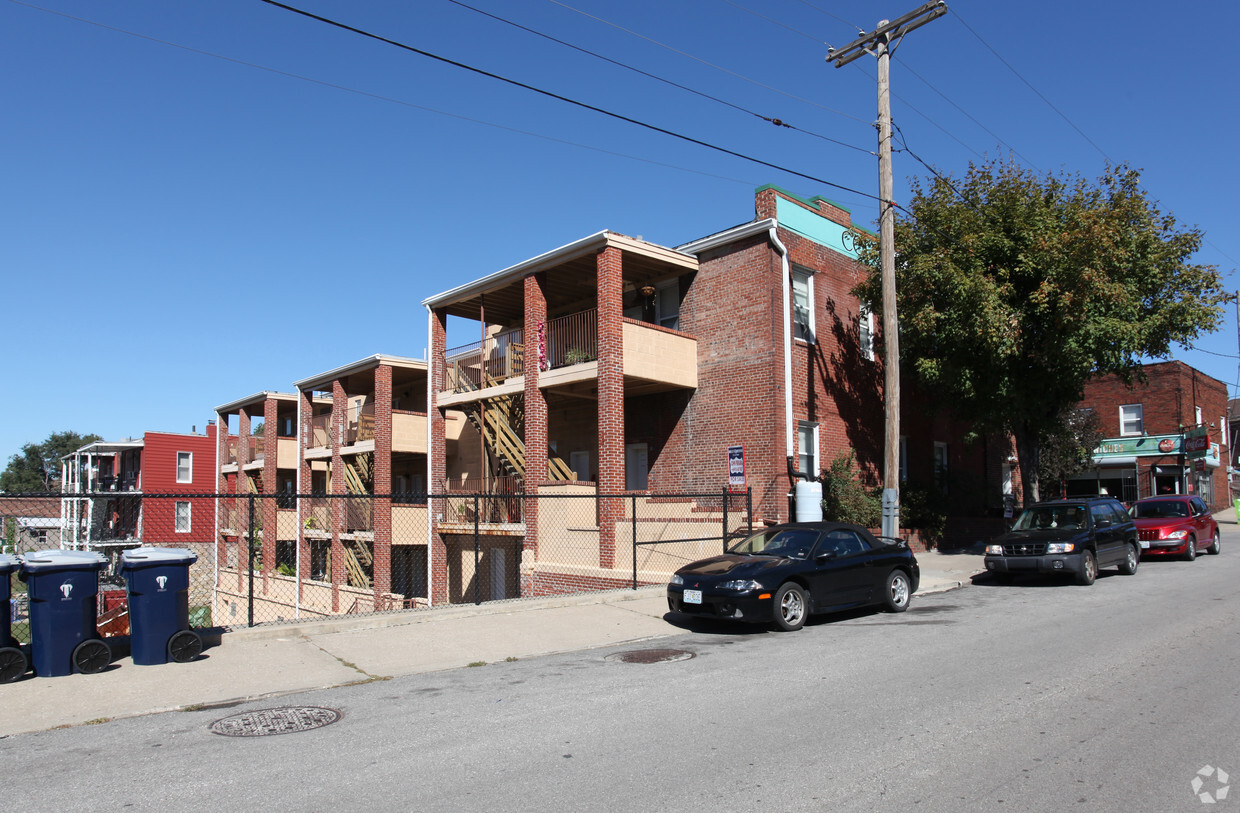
<box><xmin>667</xmin><ymin>522</ymin><xmax>921</xmax><ymax>631</ymax></box>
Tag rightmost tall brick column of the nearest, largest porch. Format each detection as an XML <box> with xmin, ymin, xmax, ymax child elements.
<box><xmin>596</xmin><ymin>247</ymin><xmax>625</xmax><ymax>568</ymax></box>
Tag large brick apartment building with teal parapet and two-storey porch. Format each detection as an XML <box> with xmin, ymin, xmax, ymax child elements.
<box><xmin>423</xmin><ymin>186</ymin><xmax>1011</xmax><ymax>602</ymax></box>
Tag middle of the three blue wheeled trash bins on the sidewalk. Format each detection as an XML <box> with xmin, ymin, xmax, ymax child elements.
<box><xmin>20</xmin><ymin>550</ymin><xmax>112</xmax><ymax>678</ymax></box>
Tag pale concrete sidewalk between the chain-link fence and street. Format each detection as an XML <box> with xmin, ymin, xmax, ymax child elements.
<box><xmin>0</xmin><ymin>553</ymin><xmax>982</xmax><ymax>736</ymax></box>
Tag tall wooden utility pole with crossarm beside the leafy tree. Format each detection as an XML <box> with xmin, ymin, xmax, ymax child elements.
<box><xmin>827</xmin><ymin>0</ymin><xmax>947</xmax><ymax>538</ymax></box>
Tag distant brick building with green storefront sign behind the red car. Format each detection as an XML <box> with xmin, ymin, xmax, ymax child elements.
<box><xmin>1066</xmin><ymin>361</ymin><xmax>1230</xmax><ymax>511</ymax></box>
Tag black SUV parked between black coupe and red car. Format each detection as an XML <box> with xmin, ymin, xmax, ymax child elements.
<box><xmin>983</xmin><ymin>497</ymin><xmax>1141</xmax><ymax>585</ymax></box>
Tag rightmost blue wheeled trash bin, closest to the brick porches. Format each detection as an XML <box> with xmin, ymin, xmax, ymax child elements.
<box><xmin>120</xmin><ymin>548</ymin><xmax>202</xmax><ymax>666</ymax></box>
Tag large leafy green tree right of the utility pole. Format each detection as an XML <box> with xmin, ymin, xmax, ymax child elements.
<box><xmin>858</xmin><ymin>160</ymin><xmax>1224</xmax><ymax>502</ymax></box>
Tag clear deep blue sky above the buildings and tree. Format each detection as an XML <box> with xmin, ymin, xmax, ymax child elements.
<box><xmin>0</xmin><ymin>0</ymin><xmax>1240</xmax><ymax>465</ymax></box>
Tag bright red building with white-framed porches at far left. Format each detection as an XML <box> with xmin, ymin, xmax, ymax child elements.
<box><xmin>60</xmin><ymin>424</ymin><xmax>216</xmax><ymax>555</ymax></box>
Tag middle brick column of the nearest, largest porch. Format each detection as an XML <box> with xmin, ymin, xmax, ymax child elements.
<box><xmin>520</xmin><ymin>274</ymin><xmax>548</xmax><ymax>596</ymax></box>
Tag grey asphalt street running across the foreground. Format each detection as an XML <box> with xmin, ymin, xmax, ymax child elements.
<box><xmin>0</xmin><ymin>525</ymin><xmax>1240</xmax><ymax>812</ymax></box>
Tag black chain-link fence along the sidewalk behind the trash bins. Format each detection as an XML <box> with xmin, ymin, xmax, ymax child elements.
<box><xmin>0</xmin><ymin>483</ymin><xmax>753</xmax><ymax>641</ymax></box>
